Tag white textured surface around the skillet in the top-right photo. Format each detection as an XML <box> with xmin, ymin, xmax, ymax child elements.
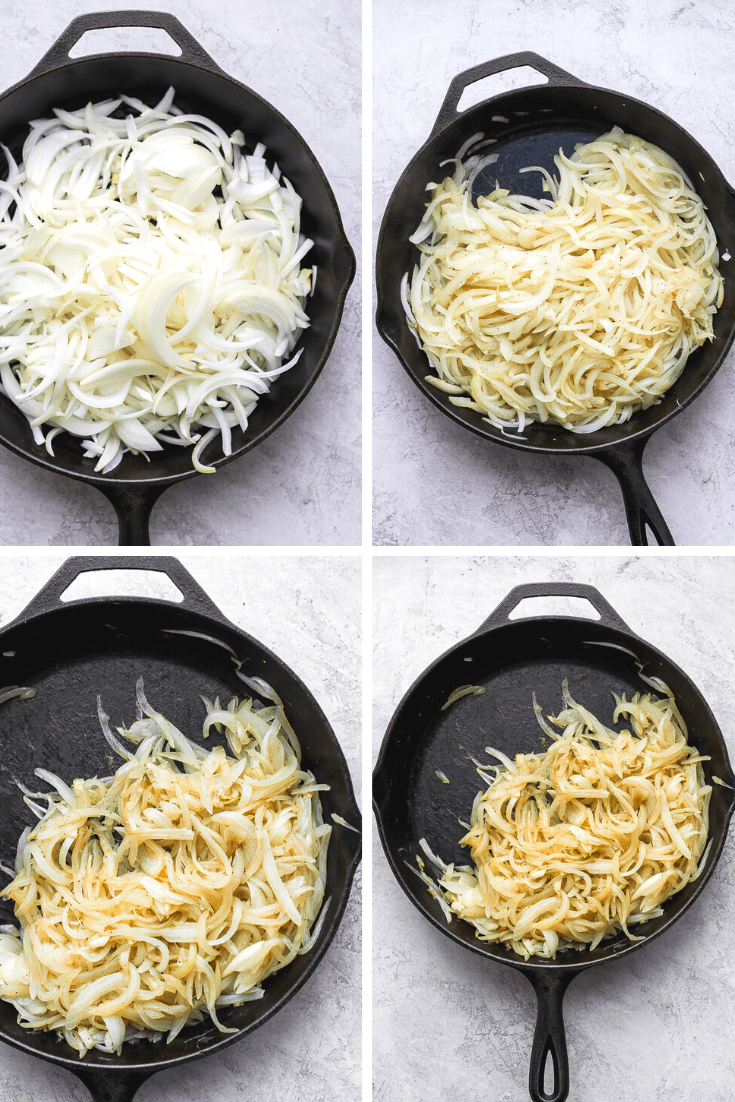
<box><xmin>372</xmin><ymin>0</ymin><xmax>735</xmax><ymax>547</ymax></box>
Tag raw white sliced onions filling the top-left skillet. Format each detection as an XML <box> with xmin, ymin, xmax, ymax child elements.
<box><xmin>0</xmin><ymin>88</ymin><xmax>315</xmax><ymax>473</ymax></box>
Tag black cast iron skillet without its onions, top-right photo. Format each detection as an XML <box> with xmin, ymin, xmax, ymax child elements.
<box><xmin>376</xmin><ymin>53</ymin><xmax>735</xmax><ymax>545</ymax></box>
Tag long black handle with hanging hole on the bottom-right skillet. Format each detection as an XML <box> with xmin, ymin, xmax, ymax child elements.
<box><xmin>526</xmin><ymin>969</ymin><xmax>573</xmax><ymax>1102</ymax></box>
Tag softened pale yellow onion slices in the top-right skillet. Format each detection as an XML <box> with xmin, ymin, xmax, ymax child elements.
<box><xmin>402</xmin><ymin>127</ymin><xmax>723</xmax><ymax>433</ymax></box>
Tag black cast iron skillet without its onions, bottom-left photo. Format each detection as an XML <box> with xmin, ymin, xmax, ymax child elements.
<box><xmin>0</xmin><ymin>557</ymin><xmax>360</xmax><ymax>1102</ymax></box>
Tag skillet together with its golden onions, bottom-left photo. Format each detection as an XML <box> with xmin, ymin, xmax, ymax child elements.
<box><xmin>0</xmin><ymin>557</ymin><xmax>360</xmax><ymax>1102</ymax></box>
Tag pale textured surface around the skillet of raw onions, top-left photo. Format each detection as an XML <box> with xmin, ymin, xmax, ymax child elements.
<box><xmin>0</xmin><ymin>0</ymin><xmax>361</xmax><ymax>547</ymax></box>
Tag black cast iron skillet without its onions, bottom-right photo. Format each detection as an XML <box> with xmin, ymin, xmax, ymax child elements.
<box><xmin>374</xmin><ymin>582</ymin><xmax>735</xmax><ymax>1102</ymax></box>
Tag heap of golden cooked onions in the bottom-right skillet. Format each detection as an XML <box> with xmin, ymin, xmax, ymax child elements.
<box><xmin>414</xmin><ymin>665</ymin><xmax>712</xmax><ymax>960</ymax></box>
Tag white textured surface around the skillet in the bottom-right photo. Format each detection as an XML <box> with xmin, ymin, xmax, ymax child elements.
<box><xmin>372</xmin><ymin>555</ymin><xmax>735</xmax><ymax>1102</ymax></box>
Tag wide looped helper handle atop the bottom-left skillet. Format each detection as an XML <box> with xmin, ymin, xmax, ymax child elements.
<box><xmin>12</xmin><ymin>555</ymin><xmax>229</xmax><ymax>625</ymax></box>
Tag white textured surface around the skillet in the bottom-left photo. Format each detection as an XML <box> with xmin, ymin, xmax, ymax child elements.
<box><xmin>0</xmin><ymin>551</ymin><xmax>361</xmax><ymax>1102</ymax></box>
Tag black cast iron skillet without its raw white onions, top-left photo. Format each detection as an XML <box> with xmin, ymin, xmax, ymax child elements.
<box><xmin>0</xmin><ymin>11</ymin><xmax>355</xmax><ymax>545</ymax></box>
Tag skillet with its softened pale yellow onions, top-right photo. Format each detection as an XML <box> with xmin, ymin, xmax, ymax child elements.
<box><xmin>376</xmin><ymin>52</ymin><xmax>735</xmax><ymax>545</ymax></box>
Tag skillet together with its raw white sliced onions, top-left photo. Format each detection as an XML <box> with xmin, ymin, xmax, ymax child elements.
<box><xmin>0</xmin><ymin>11</ymin><xmax>355</xmax><ymax>545</ymax></box>
